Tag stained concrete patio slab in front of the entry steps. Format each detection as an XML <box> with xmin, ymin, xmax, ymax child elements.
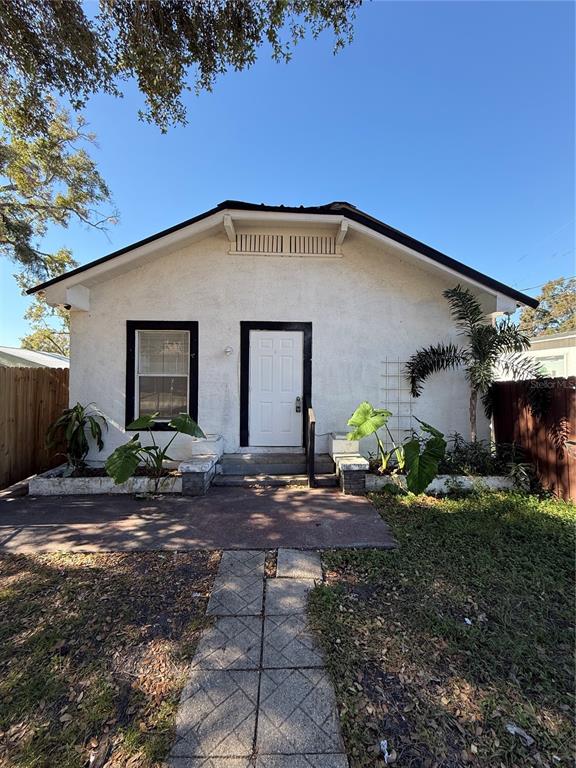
<box><xmin>0</xmin><ymin>488</ymin><xmax>395</xmax><ymax>552</ymax></box>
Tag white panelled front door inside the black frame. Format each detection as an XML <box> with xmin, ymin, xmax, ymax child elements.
<box><xmin>248</xmin><ymin>331</ymin><xmax>304</xmax><ymax>446</ymax></box>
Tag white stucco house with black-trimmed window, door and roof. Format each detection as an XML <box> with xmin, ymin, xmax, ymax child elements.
<box><xmin>30</xmin><ymin>200</ymin><xmax>536</xmax><ymax>468</ymax></box>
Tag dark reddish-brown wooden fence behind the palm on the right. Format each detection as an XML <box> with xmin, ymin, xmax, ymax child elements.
<box><xmin>494</xmin><ymin>376</ymin><xmax>576</xmax><ymax>501</ymax></box>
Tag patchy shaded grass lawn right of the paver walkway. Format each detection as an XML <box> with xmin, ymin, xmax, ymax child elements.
<box><xmin>310</xmin><ymin>494</ymin><xmax>576</xmax><ymax>768</ymax></box>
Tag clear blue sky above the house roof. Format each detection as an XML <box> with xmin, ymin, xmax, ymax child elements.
<box><xmin>0</xmin><ymin>0</ymin><xmax>576</xmax><ymax>346</ymax></box>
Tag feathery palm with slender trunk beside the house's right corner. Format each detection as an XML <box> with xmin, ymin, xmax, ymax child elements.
<box><xmin>406</xmin><ymin>285</ymin><xmax>541</xmax><ymax>441</ymax></box>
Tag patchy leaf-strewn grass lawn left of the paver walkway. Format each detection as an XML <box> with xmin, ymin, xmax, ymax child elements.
<box><xmin>0</xmin><ymin>552</ymin><xmax>219</xmax><ymax>768</ymax></box>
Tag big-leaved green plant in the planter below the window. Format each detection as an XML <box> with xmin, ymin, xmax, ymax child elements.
<box><xmin>106</xmin><ymin>413</ymin><xmax>206</xmax><ymax>493</ymax></box>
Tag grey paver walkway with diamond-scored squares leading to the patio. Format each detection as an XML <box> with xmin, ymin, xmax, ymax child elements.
<box><xmin>168</xmin><ymin>549</ymin><xmax>348</xmax><ymax>768</ymax></box>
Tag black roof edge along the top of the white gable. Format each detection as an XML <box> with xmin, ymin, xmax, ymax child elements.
<box><xmin>27</xmin><ymin>200</ymin><xmax>538</xmax><ymax>308</ymax></box>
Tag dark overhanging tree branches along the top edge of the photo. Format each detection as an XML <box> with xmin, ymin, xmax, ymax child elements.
<box><xmin>0</xmin><ymin>0</ymin><xmax>361</xmax><ymax>131</ymax></box>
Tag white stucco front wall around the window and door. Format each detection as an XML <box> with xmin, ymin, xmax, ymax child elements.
<box><xmin>70</xmin><ymin>226</ymin><xmax>488</xmax><ymax>459</ymax></box>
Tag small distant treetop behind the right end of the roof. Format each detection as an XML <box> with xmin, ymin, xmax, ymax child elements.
<box><xmin>520</xmin><ymin>277</ymin><xmax>576</xmax><ymax>336</ymax></box>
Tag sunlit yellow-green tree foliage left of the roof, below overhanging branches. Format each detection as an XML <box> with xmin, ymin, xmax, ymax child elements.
<box><xmin>0</xmin><ymin>99</ymin><xmax>114</xmax><ymax>281</ymax></box>
